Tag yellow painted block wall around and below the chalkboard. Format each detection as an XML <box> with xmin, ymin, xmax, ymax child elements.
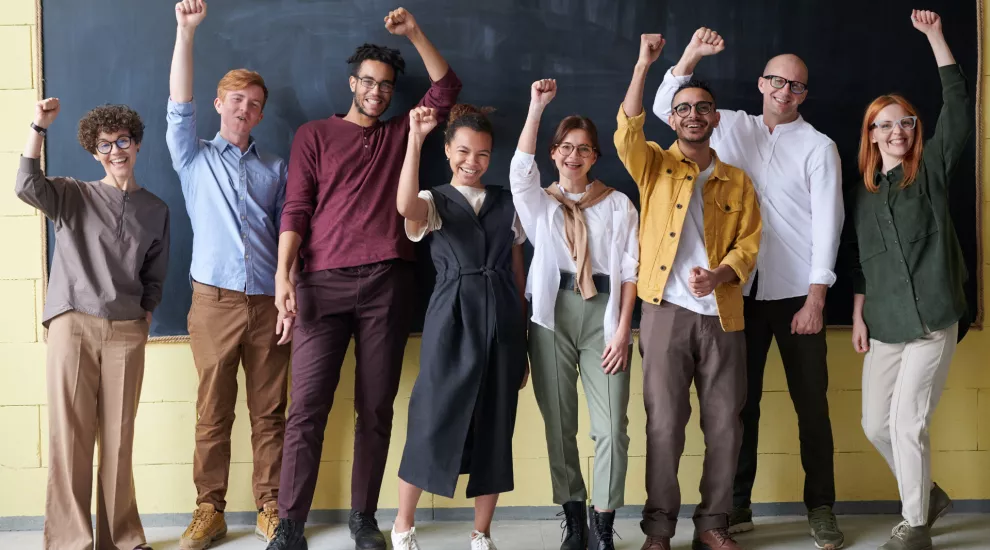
<box><xmin>0</xmin><ymin>0</ymin><xmax>990</xmax><ymax>517</ymax></box>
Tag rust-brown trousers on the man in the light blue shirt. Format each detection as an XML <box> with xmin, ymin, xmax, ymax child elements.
<box><xmin>187</xmin><ymin>281</ymin><xmax>290</xmax><ymax>511</ymax></box>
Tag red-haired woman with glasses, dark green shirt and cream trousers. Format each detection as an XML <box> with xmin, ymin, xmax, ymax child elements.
<box><xmin>851</xmin><ymin>10</ymin><xmax>972</xmax><ymax>550</ymax></box>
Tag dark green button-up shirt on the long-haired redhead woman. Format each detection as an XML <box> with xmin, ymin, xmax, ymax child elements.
<box><xmin>850</xmin><ymin>65</ymin><xmax>973</xmax><ymax>343</ymax></box>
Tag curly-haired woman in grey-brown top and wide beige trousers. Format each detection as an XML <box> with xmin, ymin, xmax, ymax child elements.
<box><xmin>16</xmin><ymin>98</ymin><xmax>169</xmax><ymax>550</ymax></box>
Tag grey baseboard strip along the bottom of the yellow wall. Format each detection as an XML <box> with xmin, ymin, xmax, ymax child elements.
<box><xmin>0</xmin><ymin>500</ymin><xmax>990</xmax><ymax>531</ymax></box>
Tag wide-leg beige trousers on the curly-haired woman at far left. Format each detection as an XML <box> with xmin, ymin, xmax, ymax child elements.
<box><xmin>45</xmin><ymin>311</ymin><xmax>148</xmax><ymax>550</ymax></box>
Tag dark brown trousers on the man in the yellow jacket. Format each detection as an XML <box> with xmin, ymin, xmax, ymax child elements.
<box><xmin>639</xmin><ymin>302</ymin><xmax>746</xmax><ymax>537</ymax></box>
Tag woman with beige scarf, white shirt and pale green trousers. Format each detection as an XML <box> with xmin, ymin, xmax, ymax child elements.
<box><xmin>509</xmin><ymin>79</ymin><xmax>639</xmax><ymax>550</ymax></box>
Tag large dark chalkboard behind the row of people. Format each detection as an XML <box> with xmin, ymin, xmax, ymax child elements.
<box><xmin>42</xmin><ymin>0</ymin><xmax>981</xmax><ymax>336</ymax></box>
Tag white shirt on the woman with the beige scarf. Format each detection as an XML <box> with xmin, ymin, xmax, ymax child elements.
<box><xmin>509</xmin><ymin>150</ymin><xmax>639</xmax><ymax>345</ymax></box>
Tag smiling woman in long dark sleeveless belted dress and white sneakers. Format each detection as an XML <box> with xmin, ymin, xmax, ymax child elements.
<box><xmin>392</xmin><ymin>105</ymin><xmax>527</xmax><ymax>550</ymax></box>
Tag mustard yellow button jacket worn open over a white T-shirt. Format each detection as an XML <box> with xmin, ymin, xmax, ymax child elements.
<box><xmin>615</xmin><ymin>107</ymin><xmax>763</xmax><ymax>332</ymax></box>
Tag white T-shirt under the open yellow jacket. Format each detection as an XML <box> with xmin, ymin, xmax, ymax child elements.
<box><xmin>663</xmin><ymin>164</ymin><xmax>718</xmax><ymax>317</ymax></box>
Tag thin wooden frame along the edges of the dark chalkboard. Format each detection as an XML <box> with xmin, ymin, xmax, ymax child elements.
<box><xmin>34</xmin><ymin>0</ymin><xmax>990</xmax><ymax>343</ymax></box>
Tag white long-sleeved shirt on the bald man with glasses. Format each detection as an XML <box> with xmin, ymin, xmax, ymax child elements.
<box><xmin>653</xmin><ymin>70</ymin><xmax>845</xmax><ymax>300</ymax></box>
